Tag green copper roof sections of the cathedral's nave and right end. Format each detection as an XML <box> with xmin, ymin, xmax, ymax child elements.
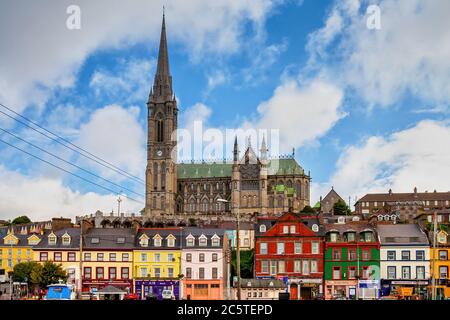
<box><xmin>177</xmin><ymin>159</ymin><xmax>304</xmax><ymax>179</ymax></box>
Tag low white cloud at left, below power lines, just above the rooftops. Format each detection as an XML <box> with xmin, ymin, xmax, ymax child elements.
<box><xmin>0</xmin><ymin>165</ymin><xmax>143</xmax><ymax>221</ymax></box>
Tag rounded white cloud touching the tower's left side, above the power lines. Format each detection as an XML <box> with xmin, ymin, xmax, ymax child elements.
<box><xmin>75</xmin><ymin>105</ymin><xmax>146</xmax><ymax>180</ymax></box>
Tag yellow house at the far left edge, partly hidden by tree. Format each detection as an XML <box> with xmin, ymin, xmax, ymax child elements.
<box><xmin>0</xmin><ymin>228</ymin><xmax>41</xmax><ymax>281</ymax></box>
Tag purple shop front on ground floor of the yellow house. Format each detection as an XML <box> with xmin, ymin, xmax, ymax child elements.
<box><xmin>134</xmin><ymin>279</ymin><xmax>180</xmax><ymax>300</ymax></box>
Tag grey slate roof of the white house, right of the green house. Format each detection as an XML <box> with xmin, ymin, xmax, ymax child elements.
<box><xmin>377</xmin><ymin>223</ymin><xmax>429</xmax><ymax>245</ymax></box>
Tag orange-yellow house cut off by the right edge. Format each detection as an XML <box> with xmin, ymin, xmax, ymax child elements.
<box><xmin>430</xmin><ymin>230</ymin><xmax>450</xmax><ymax>299</ymax></box>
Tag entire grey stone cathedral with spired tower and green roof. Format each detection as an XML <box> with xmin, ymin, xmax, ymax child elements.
<box><xmin>144</xmin><ymin>16</ymin><xmax>311</xmax><ymax>221</ymax></box>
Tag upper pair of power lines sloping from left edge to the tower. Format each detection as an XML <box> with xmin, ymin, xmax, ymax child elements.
<box><xmin>0</xmin><ymin>103</ymin><xmax>145</xmax><ymax>184</ymax></box>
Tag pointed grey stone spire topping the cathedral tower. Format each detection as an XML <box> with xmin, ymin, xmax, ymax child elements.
<box><xmin>150</xmin><ymin>13</ymin><xmax>173</xmax><ymax>102</ymax></box>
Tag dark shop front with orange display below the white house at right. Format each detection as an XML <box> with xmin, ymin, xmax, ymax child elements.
<box><xmin>381</xmin><ymin>280</ymin><xmax>429</xmax><ymax>300</ymax></box>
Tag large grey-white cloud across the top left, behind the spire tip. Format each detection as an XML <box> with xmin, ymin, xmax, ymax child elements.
<box><xmin>0</xmin><ymin>0</ymin><xmax>278</xmax><ymax>111</ymax></box>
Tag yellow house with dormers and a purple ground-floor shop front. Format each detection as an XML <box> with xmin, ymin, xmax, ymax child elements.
<box><xmin>133</xmin><ymin>227</ymin><xmax>182</xmax><ymax>299</ymax></box>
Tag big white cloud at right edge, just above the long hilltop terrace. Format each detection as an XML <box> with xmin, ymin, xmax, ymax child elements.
<box><xmin>314</xmin><ymin>120</ymin><xmax>450</xmax><ymax>199</ymax></box>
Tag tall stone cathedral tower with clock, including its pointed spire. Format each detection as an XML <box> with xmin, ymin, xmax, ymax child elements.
<box><xmin>145</xmin><ymin>15</ymin><xmax>178</xmax><ymax>218</ymax></box>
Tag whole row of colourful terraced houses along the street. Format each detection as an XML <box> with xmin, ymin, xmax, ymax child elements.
<box><xmin>0</xmin><ymin>212</ymin><xmax>450</xmax><ymax>300</ymax></box>
